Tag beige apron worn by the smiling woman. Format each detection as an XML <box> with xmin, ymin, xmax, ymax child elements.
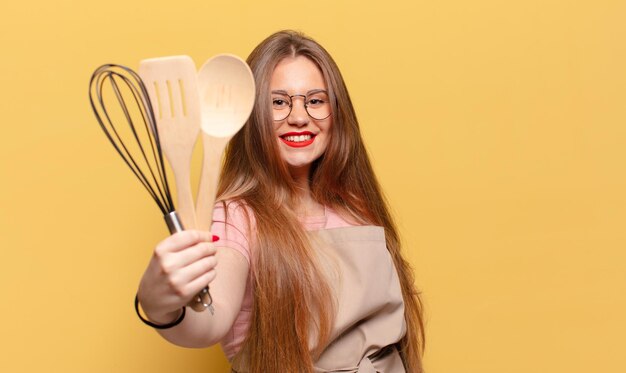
<box><xmin>232</xmin><ymin>226</ymin><xmax>406</xmax><ymax>373</ymax></box>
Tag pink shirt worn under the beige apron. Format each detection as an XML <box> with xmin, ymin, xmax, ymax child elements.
<box><xmin>211</xmin><ymin>203</ymin><xmax>353</xmax><ymax>359</ymax></box>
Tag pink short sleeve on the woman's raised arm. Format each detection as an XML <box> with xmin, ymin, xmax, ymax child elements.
<box><xmin>211</xmin><ymin>201</ymin><xmax>254</xmax><ymax>264</ymax></box>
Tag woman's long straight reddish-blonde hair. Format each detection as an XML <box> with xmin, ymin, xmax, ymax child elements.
<box><xmin>218</xmin><ymin>31</ymin><xmax>424</xmax><ymax>373</ymax></box>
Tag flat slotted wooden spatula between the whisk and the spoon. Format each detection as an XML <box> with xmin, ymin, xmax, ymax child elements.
<box><xmin>139</xmin><ymin>56</ymin><xmax>200</xmax><ymax>229</ymax></box>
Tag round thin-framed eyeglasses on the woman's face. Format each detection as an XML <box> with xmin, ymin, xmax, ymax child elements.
<box><xmin>272</xmin><ymin>90</ymin><xmax>330</xmax><ymax>121</ymax></box>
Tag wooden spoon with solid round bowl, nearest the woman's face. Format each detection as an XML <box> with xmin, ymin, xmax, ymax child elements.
<box><xmin>196</xmin><ymin>54</ymin><xmax>255</xmax><ymax>230</ymax></box>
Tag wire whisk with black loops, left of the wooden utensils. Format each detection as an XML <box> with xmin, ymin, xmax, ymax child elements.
<box><xmin>89</xmin><ymin>64</ymin><xmax>213</xmax><ymax>313</ymax></box>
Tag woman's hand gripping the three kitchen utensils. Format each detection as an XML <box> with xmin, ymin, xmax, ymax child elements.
<box><xmin>137</xmin><ymin>230</ymin><xmax>217</xmax><ymax>323</ymax></box>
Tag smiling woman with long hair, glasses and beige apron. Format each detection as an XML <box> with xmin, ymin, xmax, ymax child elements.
<box><xmin>138</xmin><ymin>31</ymin><xmax>424</xmax><ymax>373</ymax></box>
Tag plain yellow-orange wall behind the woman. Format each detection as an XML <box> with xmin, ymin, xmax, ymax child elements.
<box><xmin>0</xmin><ymin>0</ymin><xmax>626</xmax><ymax>373</ymax></box>
